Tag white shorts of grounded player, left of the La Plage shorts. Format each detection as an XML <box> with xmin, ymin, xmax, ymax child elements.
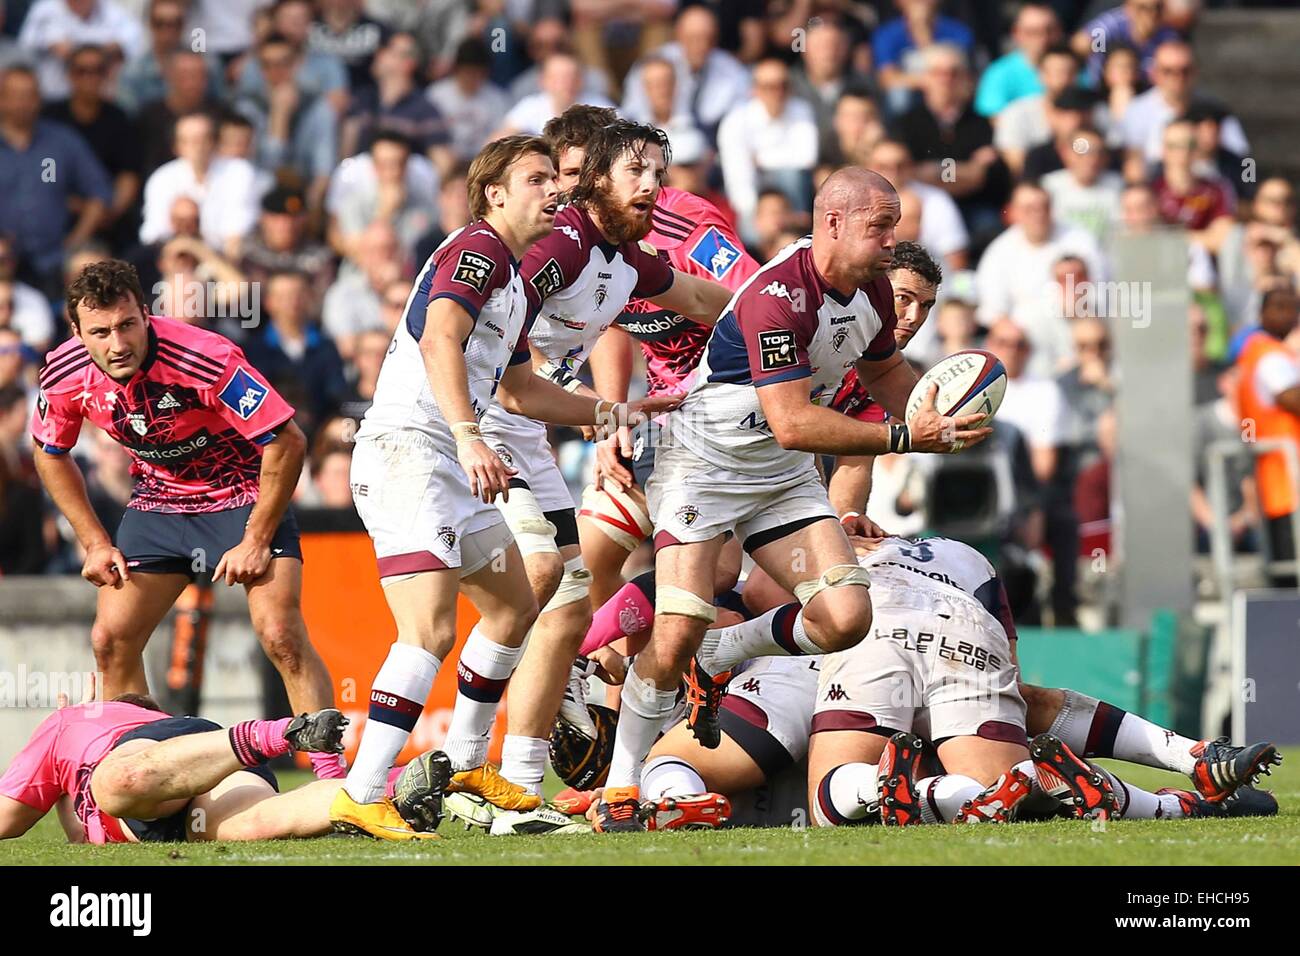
<box><xmin>719</xmin><ymin>657</ymin><xmax>822</xmax><ymax>779</ymax></box>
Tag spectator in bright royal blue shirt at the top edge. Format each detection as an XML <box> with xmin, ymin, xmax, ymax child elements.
<box><xmin>871</xmin><ymin>0</ymin><xmax>975</xmax><ymax>114</ymax></box>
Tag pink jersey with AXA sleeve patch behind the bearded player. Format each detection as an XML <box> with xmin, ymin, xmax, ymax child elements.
<box><xmin>615</xmin><ymin>186</ymin><xmax>758</xmax><ymax>395</ymax></box>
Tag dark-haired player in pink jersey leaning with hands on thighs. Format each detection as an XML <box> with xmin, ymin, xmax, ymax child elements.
<box><xmin>31</xmin><ymin>260</ymin><xmax>343</xmax><ymax>777</ymax></box>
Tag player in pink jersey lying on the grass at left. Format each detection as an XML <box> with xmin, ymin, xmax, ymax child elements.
<box><xmin>0</xmin><ymin>695</ymin><xmax>364</xmax><ymax>843</ymax></box>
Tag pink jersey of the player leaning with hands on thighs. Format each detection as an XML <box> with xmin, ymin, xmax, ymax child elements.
<box><xmin>31</xmin><ymin>316</ymin><xmax>294</xmax><ymax>512</ymax></box>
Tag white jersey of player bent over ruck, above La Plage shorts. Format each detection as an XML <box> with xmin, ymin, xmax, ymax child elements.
<box><xmin>858</xmin><ymin>537</ymin><xmax>1015</xmax><ymax>640</ymax></box>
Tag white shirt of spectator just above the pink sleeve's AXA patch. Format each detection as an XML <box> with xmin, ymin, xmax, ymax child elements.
<box><xmin>718</xmin><ymin>99</ymin><xmax>818</xmax><ymax>219</ymax></box>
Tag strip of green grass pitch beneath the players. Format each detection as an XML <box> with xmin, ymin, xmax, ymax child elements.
<box><xmin>0</xmin><ymin>749</ymin><xmax>1300</xmax><ymax>866</ymax></box>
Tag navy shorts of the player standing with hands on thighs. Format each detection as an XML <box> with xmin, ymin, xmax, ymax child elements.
<box><xmin>116</xmin><ymin>505</ymin><xmax>303</xmax><ymax>580</ymax></box>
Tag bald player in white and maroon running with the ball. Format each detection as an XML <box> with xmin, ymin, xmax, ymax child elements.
<box><xmin>597</xmin><ymin>166</ymin><xmax>989</xmax><ymax>831</ymax></box>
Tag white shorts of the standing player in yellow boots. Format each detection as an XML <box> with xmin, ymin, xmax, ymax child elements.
<box><xmin>350</xmin><ymin>432</ymin><xmax>508</xmax><ymax>578</ymax></box>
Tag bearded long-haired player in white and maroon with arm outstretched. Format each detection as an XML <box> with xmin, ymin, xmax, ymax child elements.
<box><xmin>475</xmin><ymin>120</ymin><xmax>729</xmax><ymax>823</ymax></box>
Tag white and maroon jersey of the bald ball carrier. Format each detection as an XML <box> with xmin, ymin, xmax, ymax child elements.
<box><xmin>664</xmin><ymin>235</ymin><xmax>896</xmax><ymax>477</ymax></box>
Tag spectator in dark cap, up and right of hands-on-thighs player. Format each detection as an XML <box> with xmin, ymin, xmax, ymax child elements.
<box><xmin>239</xmin><ymin>186</ymin><xmax>334</xmax><ymax>306</ymax></box>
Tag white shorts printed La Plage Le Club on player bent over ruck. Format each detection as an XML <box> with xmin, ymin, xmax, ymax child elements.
<box><xmin>813</xmin><ymin>579</ymin><xmax>1026</xmax><ymax>744</ymax></box>
